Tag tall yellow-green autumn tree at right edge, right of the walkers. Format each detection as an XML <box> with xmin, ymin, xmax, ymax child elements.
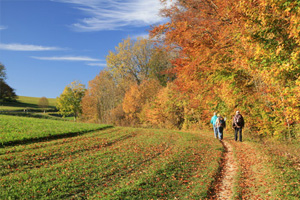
<box><xmin>239</xmin><ymin>0</ymin><xmax>300</xmax><ymax>139</ymax></box>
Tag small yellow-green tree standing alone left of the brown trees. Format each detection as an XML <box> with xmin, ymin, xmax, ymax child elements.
<box><xmin>56</xmin><ymin>81</ymin><xmax>86</xmax><ymax>120</ymax></box>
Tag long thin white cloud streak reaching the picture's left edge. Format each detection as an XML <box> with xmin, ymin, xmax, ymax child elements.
<box><xmin>0</xmin><ymin>43</ymin><xmax>64</xmax><ymax>51</ymax></box>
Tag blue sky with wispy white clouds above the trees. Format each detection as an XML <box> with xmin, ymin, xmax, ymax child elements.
<box><xmin>0</xmin><ymin>0</ymin><xmax>171</xmax><ymax>98</ymax></box>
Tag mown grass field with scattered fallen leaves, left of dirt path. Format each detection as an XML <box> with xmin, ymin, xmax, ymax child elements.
<box><xmin>0</xmin><ymin>115</ymin><xmax>223</xmax><ymax>199</ymax></box>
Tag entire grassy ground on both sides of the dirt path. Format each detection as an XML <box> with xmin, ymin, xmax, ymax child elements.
<box><xmin>0</xmin><ymin>111</ymin><xmax>300</xmax><ymax>200</ymax></box>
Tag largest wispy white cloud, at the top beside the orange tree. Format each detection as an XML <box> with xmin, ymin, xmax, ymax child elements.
<box><xmin>53</xmin><ymin>0</ymin><xmax>172</xmax><ymax>31</ymax></box>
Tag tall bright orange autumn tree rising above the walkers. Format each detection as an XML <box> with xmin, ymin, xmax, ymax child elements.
<box><xmin>151</xmin><ymin>0</ymin><xmax>253</xmax><ymax>127</ymax></box>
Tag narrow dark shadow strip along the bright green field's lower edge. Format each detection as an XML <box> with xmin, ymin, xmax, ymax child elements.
<box><xmin>0</xmin><ymin>125</ymin><xmax>113</xmax><ymax>148</ymax></box>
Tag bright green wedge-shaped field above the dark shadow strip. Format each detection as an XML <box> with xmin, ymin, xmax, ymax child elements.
<box><xmin>0</xmin><ymin>115</ymin><xmax>111</xmax><ymax>145</ymax></box>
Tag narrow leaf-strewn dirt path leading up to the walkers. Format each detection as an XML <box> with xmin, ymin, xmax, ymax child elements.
<box><xmin>214</xmin><ymin>140</ymin><xmax>238</xmax><ymax>200</ymax></box>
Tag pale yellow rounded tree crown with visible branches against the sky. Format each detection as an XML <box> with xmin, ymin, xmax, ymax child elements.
<box><xmin>106</xmin><ymin>38</ymin><xmax>172</xmax><ymax>85</ymax></box>
